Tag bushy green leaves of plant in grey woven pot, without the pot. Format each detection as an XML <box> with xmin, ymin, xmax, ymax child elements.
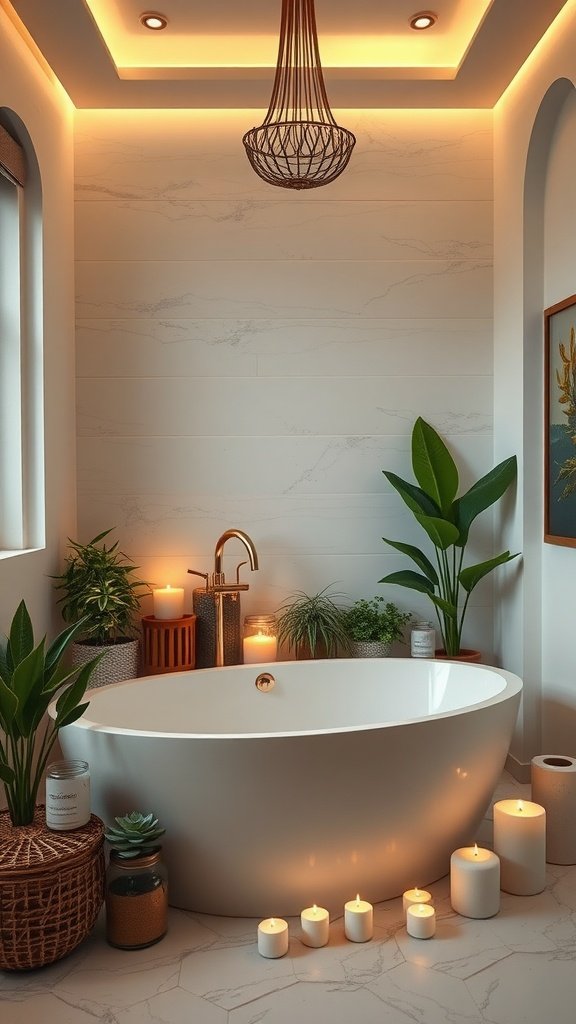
<box><xmin>52</xmin><ymin>529</ymin><xmax>150</xmax><ymax>643</ymax></box>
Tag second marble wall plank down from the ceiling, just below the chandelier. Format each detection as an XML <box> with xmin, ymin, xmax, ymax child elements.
<box><xmin>76</xmin><ymin>193</ymin><xmax>492</xmax><ymax>261</ymax></box>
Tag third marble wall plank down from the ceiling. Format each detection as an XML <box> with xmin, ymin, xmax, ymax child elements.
<box><xmin>76</xmin><ymin>259</ymin><xmax>492</xmax><ymax>319</ymax></box>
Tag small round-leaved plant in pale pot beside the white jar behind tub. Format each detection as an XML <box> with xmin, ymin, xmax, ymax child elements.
<box><xmin>343</xmin><ymin>595</ymin><xmax>412</xmax><ymax>657</ymax></box>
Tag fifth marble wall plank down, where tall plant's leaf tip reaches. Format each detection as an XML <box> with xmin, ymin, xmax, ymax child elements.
<box><xmin>78</xmin><ymin>372</ymin><xmax>492</xmax><ymax>444</ymax></box>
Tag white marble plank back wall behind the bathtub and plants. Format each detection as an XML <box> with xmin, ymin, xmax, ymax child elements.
<box><xmin>76</xmin><ymin>111</ymin><xmax>492</xmax><ymax>650</ymax></box>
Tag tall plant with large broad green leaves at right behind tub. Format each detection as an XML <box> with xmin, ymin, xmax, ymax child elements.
<box><xmin>380</xmin><ymin>417</ymin><xmax>517</xmax><ymax>656</ymax></box>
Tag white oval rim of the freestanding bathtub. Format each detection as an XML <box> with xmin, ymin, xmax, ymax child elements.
<box><xmin>48</xmin><ymin>657</ymin><xmax>524</xmax><ymax>740</ymax></box>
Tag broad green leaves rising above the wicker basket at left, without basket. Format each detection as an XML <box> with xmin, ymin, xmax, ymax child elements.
<box><xmin>0</xmin><ymin>601</ymin><xmax>102</xmax><ymax>825</ymax></box>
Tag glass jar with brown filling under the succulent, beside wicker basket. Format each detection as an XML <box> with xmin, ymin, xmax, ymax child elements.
<box><xmin>106</xmin><ymin>847</ymin><xmax>168</xmax><ymax>949</ymax></box>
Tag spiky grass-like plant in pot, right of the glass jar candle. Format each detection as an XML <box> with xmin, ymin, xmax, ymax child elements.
<box><xmin>278</xmin><ymin>584</ymin><xmax>348</xmax><ymax>660</ymax></box>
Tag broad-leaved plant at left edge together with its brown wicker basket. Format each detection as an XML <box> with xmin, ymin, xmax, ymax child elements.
<box><xmin>0</xmin><ymin>601</ymin><xmax>105</xmax><ymax>970</ymax></box>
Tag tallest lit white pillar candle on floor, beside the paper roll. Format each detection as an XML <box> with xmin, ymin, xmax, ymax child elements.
<box><xmin>494</xmin><ymin>800</ymin><xmax>546</xmax><ymax>896</ymax></box>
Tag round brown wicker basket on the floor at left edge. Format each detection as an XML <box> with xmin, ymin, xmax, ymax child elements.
<box><xmin>0</xmin><ymin>807</ymin><xmax>105</xmax><ymax>971</ymax></box>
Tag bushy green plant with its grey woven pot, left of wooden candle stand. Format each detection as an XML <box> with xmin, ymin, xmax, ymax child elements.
<box><xmin>52</xmin><ymin>529</ymin><xmax>150</xmax><ymax>686</ymax></box>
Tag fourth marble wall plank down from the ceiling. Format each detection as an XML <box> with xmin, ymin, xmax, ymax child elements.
<box><xmin>76</xmin><ymin>316</ymin><xmax>492</xmax><ymax>381</ymax></box>
